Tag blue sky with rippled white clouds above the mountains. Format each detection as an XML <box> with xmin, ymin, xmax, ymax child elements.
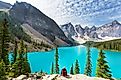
<box><xmin>1</xmin><ymin>0</ymin><xmax>121</xmax><ymax>27</ymax></box>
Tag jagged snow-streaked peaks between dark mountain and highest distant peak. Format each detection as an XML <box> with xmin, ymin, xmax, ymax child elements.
<box><xmin>60</xmin><ymin>23</ymin><xmax>99</xmax><ymax>43</ymax></box>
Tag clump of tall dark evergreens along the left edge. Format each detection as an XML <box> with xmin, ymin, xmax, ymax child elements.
<box><xmin>0</xmin><ymin>19</ymin><xmax>31</xmax><ymax>80</ymax></box>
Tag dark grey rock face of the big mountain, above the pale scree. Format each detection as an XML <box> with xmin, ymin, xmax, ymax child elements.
<box><xmin>9</xmin><ymin>2</ymin><xmax>73</xmax><ymax>45</ymax></box>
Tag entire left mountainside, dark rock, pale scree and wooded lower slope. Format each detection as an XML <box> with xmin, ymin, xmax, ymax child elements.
<box><xmin>0</xmin><ymin>2</ymin><xmax>73</xmax><ymax>47</ymax></box>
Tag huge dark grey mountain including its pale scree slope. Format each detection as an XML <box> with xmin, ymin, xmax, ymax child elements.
<box><xmin>9</xmin><ymin>2</ymin><xmax>73</xmax><ymax>46</ymax></box>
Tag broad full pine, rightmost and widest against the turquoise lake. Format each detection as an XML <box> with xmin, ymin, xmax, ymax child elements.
<box><xmin>96</xmin><ymin>50</ymin><xmax>112</xmax><ymax>80</ymax></box>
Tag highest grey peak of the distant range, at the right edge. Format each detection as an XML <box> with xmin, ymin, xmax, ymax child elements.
<box><xmin>96</xmin><ymin>20</ymin><xmax>121</xmax><ymax>37</ymax></box>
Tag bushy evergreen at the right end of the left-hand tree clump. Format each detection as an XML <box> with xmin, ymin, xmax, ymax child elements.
<box><xmin>12</xmin><ymin>40</ymin><xmax>31</xmax><ymax>77</ymax></box>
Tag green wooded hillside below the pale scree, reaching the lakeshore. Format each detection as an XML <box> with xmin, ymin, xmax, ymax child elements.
<box><xmin>0</xmin><ymin>11</ymin><xmax>52</xmax><ymax>51</ymax></box>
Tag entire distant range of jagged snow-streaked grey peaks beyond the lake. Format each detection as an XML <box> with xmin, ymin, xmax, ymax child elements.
<box><xmin>61</xmin><ymin>20</ymin><xmax>121</xmax><ymax>43</ymax></box>
